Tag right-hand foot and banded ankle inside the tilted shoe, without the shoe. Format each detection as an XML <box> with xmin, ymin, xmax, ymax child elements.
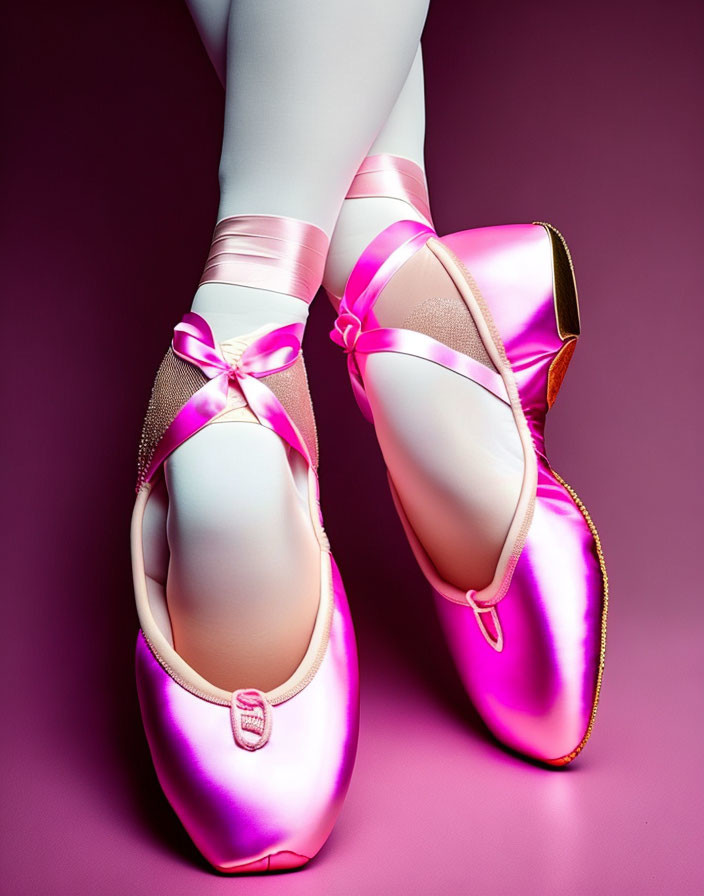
<box><xmin>325</xmin><ymin>155</ymin><xmax>523</xmax><ymax>591</ymax></box>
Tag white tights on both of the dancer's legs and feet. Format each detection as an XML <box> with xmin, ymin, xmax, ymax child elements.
<box><xmin>151</xmin><ymin>0</ymin><xmax>523</xmax><ymax>689</ymax></box>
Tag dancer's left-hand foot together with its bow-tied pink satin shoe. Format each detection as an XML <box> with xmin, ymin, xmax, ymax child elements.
<box><xmin>132</xmin><ymin>313</ymin><xmax>358</xmax><ymax>874</ymax></box>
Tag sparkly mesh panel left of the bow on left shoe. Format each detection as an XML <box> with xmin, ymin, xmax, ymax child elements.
<box><xmin>137</xmin><ymin>349</ymin><xmax>208</xmax><ymax>488</ymax></box>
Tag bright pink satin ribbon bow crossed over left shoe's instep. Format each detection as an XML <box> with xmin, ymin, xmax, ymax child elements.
<box><xmin>145</xmin><ymin>312</ymin><xmax>312</xmax><ymax>482</ymax></box>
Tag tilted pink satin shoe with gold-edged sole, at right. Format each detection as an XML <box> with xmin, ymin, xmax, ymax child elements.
<box><xmin>331</xmin><ymin>156</ymin><xmax>608</xmax><ymax>765</ymax></box>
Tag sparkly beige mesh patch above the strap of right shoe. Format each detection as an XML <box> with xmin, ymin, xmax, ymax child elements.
<box><xmin>402</xmin><ymin>295</ymin><xmax>494</xmax><ymax>370</ymax></box>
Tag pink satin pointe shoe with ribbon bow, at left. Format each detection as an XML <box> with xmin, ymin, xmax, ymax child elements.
<box><xmin>132</xmin><ymin>228</ymin><xmax>359</xmax><ymax>873</ymax></box>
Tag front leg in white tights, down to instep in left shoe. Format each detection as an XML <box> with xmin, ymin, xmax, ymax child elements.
<box><xmin>145</xmin><ymin>0</ymin><xmax>427</xmax><ymax>689</ymax></box>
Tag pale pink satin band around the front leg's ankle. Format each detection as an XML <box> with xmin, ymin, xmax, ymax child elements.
<box><xmin>200</xmin><ymin>215</ymin><xmax>328</xmax><ymax>303</ymax></box>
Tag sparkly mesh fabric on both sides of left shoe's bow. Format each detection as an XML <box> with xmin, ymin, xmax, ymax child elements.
<box><xmin>137</xmin><ymin>349</ymin><xmax>318</xmax><ymax>489</ymax></box>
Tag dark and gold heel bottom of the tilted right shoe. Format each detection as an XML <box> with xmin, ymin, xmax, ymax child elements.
<box><xmin>534</xmin><ymin>221</ymin><xmax>580</xmax><ymax>408</ymax></box>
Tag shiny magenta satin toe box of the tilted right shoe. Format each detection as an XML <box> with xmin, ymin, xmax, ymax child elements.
<box><xmin>436</xmin><ymin>473</ymin><xmax>606</xmax><ymax>765</ymax></box>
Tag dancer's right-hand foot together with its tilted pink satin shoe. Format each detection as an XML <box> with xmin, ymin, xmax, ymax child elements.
<box><xmin>332</xmin><ymin>221</ymin><xmax>607</xmax><ymax>764</ymax></box>
